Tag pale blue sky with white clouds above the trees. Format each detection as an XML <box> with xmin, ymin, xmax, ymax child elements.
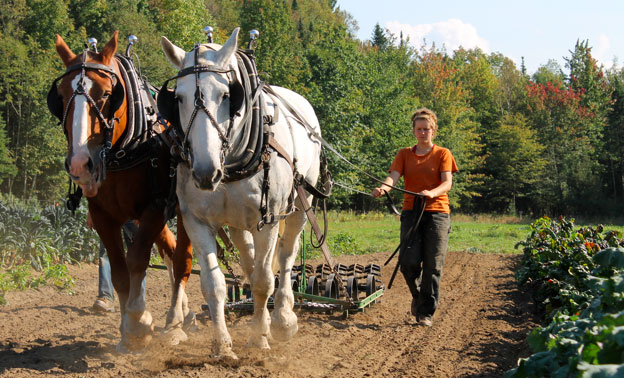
<box><xmin>338</xmin><ymin>0</ymin><xmax>624</xmax><ymax>73</ymax></box>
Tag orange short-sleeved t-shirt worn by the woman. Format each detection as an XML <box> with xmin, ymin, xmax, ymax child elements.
<box><xmin>388</xmin><ymin>144</ymin><xmax>457</xmax><ymax>214</ymax></box>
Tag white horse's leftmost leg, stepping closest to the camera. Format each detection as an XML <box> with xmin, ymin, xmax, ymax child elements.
<box><xmin>184</xmin><ymin>213</ymin><xmax>237</xmax><ymax>359</ymax></box>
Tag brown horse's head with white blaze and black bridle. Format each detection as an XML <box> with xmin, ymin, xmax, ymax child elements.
<box><xmin>48</xmin><ymin>32</ymin><xmax>126</xmax><ymax>197</ymax></box>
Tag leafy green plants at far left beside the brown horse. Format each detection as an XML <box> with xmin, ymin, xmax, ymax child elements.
<box><xmin>0</xmin><ymin>201</ymin><xmax>99</xmax><ymax>305</ymax></box>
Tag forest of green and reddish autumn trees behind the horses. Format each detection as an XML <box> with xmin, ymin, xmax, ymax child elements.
<box><xmin>0</xmin><ymin>0</ymin><xmax>624</xmax><ymax>217</ymax></box>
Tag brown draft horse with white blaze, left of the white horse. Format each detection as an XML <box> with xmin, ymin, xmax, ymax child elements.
<box><xmin>48</xmin><ymin>32</ymin><xmax>194</xmax><ymax>352</ymax></box>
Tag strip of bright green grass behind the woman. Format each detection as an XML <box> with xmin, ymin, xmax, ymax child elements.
<box><xmin>305</xmin><ymin>212</ymin><xmax>624</xmax><ymax>256</ymax></box>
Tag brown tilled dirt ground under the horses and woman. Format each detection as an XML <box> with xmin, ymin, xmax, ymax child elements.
<box><xmin>0</xmin><ymin>252</ymin><xmax>536</xmax><ymax>378</ymax></box>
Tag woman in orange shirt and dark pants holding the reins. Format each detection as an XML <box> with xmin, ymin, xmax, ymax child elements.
<box><xmin>371</xmin><ymin>108</ymin><xmax>457</xmax><ymax>327</ymax></box>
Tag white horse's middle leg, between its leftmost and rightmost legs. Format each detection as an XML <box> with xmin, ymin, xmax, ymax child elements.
<box><xmin>248</xmin><ymin>224</ymin><xmax>280</xmax><ymax>349</ymax></box>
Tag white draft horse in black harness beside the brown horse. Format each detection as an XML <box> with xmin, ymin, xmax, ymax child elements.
<box><xmin>159</xmin><ymin>28</ymin><xmax>321</xmax><ymax>358</ymax></box>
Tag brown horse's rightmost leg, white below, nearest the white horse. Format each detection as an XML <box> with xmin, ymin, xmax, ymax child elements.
<box><xmin>164</xmin><ymin>213</ymin><xmax>197</xmax><ymax>345</ymax></box>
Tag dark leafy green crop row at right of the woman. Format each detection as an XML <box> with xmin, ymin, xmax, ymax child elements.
<box><xmin>506</xmin><ymin>217</ymin><xmax>624</xmax><ymax>377</ymax></box>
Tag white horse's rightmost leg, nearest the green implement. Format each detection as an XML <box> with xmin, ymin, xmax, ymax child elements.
<box><xmin>271</xmin><ymin>211</ymin><xmax>306</xmax><ymax>341</ymax></box>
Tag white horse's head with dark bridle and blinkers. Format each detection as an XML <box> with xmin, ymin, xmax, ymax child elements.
<box><xmin>158</xmin><ymin>28</ymin><xmax>244</xmax><ymax>190</ymax></box>
